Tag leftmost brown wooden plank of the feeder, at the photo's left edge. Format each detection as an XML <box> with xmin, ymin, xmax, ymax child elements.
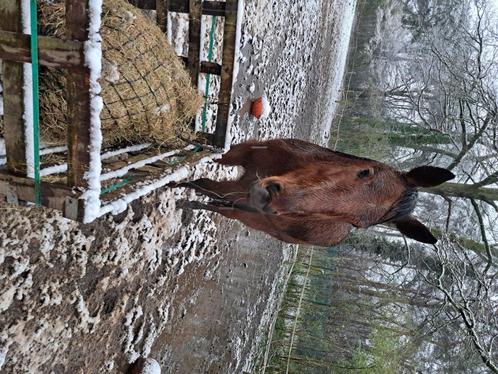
<box><xmin>0</xmin><ymin>0</ymin><xmax>26</xmax><ymax>175</ymax></box>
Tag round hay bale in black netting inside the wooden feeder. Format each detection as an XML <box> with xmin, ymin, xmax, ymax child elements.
<box><xmin>39</xmin><ymin>0</ymin><xmax>202</xmax><ymax>146</ymax></box>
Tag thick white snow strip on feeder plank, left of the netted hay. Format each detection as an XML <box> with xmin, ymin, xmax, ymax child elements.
<box><xmin>82</xmin><ymin>0</ymin><xmax>104</xmax><ymax>222</ymax></box>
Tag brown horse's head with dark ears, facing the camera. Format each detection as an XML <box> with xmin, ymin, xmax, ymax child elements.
<box><xmin>248</xmin><ymin>155</ymin><xmax>454</xmax><ymax>243</ymax></box>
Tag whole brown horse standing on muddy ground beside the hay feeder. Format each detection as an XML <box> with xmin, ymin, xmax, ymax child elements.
<box><xmin>175</xmin><ymin>139</ymin><xmax>454</xmax><ymax>246</ymax></box>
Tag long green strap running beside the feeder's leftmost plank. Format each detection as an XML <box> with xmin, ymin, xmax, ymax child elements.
<box><xmin>30</xmin><ymin>0</ymin><xmax>41</xmax><ymax>205</ymax></box>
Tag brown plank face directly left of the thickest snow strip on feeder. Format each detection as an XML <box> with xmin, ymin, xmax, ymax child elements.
<box><xmin>66</xmin><ymin>0</ymin><xmax>90</xmax><ymax>187</ymax></box>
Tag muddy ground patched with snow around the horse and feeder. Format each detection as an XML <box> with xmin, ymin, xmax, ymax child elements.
<box><xmin>0</xmin><ymin>0</ymin><xmax>354</xmax><ymax>373</ymax></box>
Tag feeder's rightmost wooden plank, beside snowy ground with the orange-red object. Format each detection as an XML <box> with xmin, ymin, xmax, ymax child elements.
<box><xmin>213</xmin><ymin>0</ymin><xmax>238</xmax><ymax>147</ymax></box>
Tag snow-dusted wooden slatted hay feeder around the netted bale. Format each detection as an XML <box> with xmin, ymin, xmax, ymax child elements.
<box><xmin>0</xmin><ymin>0</ymin><xmax>241</xmax><ymax>223</ymax></box>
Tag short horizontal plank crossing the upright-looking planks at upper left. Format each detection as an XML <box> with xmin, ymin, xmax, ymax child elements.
<box><xmin>0</xmin><ymin>31</ymin><xmax>84</xmax><ymax>67</ymax></box>
